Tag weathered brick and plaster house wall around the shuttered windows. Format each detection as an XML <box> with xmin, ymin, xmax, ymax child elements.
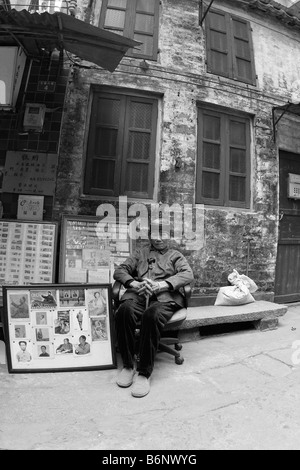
<box><xmin>54</xmin><ymin>0</ymin><xmax>300</xmax><ymax>302</ymax></box>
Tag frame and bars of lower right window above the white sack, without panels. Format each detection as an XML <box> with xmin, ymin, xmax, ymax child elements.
<box><xmin>195</xmin><ymin>104</ymin><xmax>251</xmax><ymax>209</ymax></box>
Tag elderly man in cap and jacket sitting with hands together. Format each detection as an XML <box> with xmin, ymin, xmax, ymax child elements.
<box><xmin>114</xmin><ymin>221</ymin><xmax>194</xmax><ymax>397</ymax></box>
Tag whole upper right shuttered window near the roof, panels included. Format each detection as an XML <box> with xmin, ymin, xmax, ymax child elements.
<box><xmin>206</xmin><ymin>10</ymin><xmax>256</xmax><ymax>85</ymax></box>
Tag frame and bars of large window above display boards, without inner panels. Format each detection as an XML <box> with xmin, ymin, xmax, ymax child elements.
<box><xmin>83</xmin><ymin>86</ymin><xmax>161</xmax><ymax>200</ymax></box>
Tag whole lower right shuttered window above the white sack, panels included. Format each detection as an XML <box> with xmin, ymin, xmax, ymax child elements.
<box><xmin>196</xmin><ymin>108</ymin><xmax>250</xmax><ymax>208</ymax></box>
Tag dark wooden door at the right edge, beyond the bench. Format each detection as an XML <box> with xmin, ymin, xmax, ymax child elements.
<box><xmin>274</xmin><ymin>151</ymin><xmax>300</xmax><ymax>303</ymax></box>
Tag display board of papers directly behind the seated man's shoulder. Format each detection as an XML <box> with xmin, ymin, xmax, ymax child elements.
<box><xmin>59</xmin><ymin>215</ymin><xmax>131</xmax><ymax>283</ymax></box>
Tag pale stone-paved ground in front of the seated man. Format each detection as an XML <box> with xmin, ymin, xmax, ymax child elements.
<box><xmin>0</xmin><ymin>306</ymin><xmax>300</xmax><ymax>450</ymax></box>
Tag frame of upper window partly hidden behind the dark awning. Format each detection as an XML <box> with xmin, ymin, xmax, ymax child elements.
<box><xmin>99</xmin><ymin>0</ymin><xmax>160</xmax><ymax>60</ymax></box>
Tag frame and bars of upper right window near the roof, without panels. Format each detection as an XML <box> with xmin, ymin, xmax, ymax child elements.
<box><xmin>205</xmin><ymin>9</ymin><xmax>256</xmax><ymax>86</ymax></box>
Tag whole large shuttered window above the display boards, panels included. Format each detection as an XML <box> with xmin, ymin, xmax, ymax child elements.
<box><xmin>84</xmin><ymin>92</ymin><xmax>157</xmax><ymax>198</ymax></box>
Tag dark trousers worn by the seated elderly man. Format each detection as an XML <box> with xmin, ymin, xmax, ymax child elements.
<box><xmin>115</xmin><ymin>297</ymin><xmax>181</xmax><ymax>378</ymax></box>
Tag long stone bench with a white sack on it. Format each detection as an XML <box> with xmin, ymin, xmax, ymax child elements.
<box><xmin>166</xmin><ymin>300</ymin><xmax>288</xmax><ymax>341</ymax></box>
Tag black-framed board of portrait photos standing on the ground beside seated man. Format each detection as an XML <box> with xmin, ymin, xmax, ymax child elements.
<box><xmin>3</xmin><ymin>283</ymin><xmax>117</xmax><ymax>373</ymax></box>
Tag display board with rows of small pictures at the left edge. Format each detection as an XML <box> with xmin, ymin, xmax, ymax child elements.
<box><xmin>0</xmin><ymin>219</ymin><xmax>57</xmax><ymax>305</ymax></box>
